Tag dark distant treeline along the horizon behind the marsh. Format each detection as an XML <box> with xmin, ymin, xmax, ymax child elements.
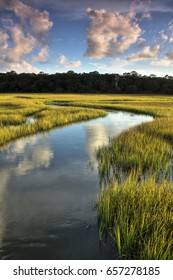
<box><xmin>0</xmin><ymin>70</ymin><xmax>173</xmax><ymax>95</ymax></box>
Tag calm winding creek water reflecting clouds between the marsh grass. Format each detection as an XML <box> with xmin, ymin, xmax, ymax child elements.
<box><xmin>0</xmin><ymin>112</ymin><xmax>152</xmax><ymax>260</ymax></box>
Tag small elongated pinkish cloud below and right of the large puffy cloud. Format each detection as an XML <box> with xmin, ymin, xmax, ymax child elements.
<box><xmin>128</xmin><ymin>44</ymin><xmax>161</xmax><ymax>61</ymax></box>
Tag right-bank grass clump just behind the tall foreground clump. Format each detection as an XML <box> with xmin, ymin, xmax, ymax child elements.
<box><xmin>97</xmin><ymin>124</ymin><xmax>173</xmax><ymax>182</ymax></box>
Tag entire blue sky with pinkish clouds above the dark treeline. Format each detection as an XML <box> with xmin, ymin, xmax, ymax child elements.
<box><xmin>0</xmin><ymin>0</ymin><xmax>173</xmax><ymax>76</ymax></box>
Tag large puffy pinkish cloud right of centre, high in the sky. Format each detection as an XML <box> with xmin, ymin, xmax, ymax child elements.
<box><xmin>85</xmin><ymin>8</ymin><xmax>142</xmax><ymax>58</ymax></box>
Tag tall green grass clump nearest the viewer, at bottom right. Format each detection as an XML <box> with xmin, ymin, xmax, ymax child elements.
<box><xmin>98</xmin><ymin>176</ymin><xmax>173</xmax><ymax>260</ymax></box>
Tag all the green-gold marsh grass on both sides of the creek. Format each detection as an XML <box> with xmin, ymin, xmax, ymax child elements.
<box><xmin>0</xmin><ymin>94</ymin><xmax>173</xmax><ymax>259</ymax></box>
